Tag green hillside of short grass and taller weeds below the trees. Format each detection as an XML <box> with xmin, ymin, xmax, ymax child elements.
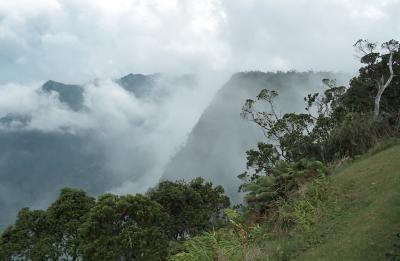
<box><xmin>170</xmin><ymin>141</ymin><xmax>400</xmax><ymax>261</ymax></box>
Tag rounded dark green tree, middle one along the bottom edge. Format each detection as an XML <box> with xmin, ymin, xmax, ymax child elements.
<box><xmin>79</xmin><ymin>194</ymin><xmax>168</xmax><ymax>260</ymax></box>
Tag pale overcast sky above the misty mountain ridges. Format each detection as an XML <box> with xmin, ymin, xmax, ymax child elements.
<box><xmin>0</xmin><ymin>0</ymin><xmax>400</xmax><ymax>84</ymax></box>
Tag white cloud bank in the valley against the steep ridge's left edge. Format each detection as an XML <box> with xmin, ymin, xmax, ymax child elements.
<box><xmin>0</xmin><ymin>76</ymin><xmax>216</xmax><ymax>190</ymax></box>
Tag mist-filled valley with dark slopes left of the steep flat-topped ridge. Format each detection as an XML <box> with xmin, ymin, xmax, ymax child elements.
<box><xmin>0</xmin><ymin>74</ymin><xmax>225</xmax><ymax>227</ymax></box>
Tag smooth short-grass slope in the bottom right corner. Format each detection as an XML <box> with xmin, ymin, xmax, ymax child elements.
<box><xmin>295</xmin><ymin>145</ymin><xmax>400</xmax><ymax>261</ymax></box>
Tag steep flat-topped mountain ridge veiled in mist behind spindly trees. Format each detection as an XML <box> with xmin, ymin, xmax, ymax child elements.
<box><xmin>163</xmin><ymin>72</ymin><xmax>348</xmax><ymax>201</ymax></box>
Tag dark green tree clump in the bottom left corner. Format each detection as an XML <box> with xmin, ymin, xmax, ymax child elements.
<box><xmin>0</xmin><ymin>189</ymin><xmax>94</xmax><ymax>260</ymax></box>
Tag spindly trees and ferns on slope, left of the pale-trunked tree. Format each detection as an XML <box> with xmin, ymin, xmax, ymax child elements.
<box><xmin>239</xmin><ymin>82</ymin><xmax>380</xmax><ymax>214</ymax></box>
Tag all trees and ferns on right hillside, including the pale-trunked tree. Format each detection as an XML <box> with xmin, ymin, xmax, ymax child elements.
<box><xmin>239</xmin><ymin>40</ymin><xmax>400</xmax><ymax>216</ymax></box>
